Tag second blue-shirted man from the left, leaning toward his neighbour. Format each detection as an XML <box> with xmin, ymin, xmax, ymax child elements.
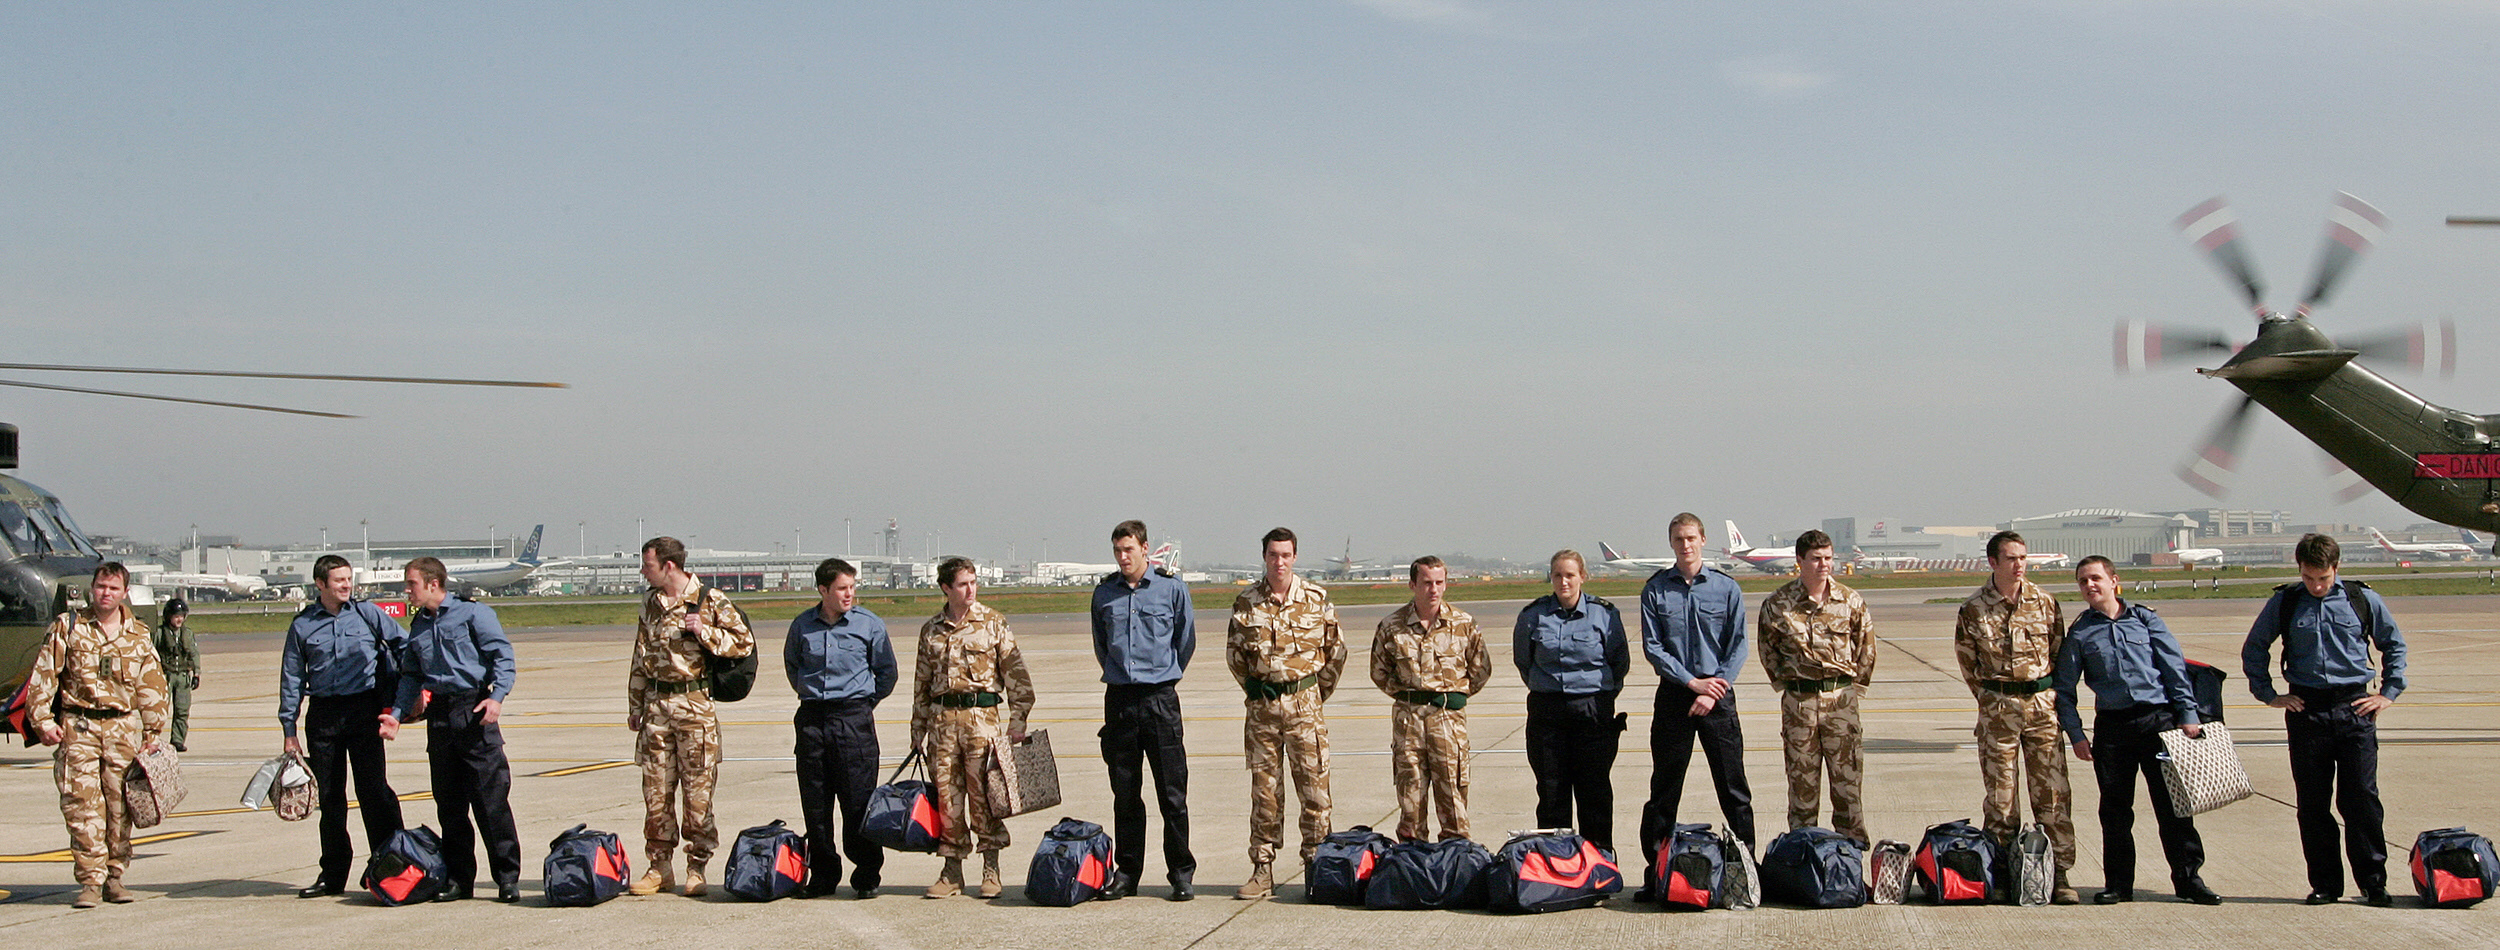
<box><xmin>383</xmin><ymin>558</ymin><xmax>520</xmax><ymax>903</ymax></box>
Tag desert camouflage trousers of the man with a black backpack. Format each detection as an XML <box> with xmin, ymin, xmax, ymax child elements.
<box><xmin>633</xmin><ymin>690</ymin><xmax>720</xmax><ymax>868</ymax></box>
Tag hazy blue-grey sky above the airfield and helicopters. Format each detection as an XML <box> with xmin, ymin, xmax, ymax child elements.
<box><xmin>0</xmin><ymin>0</ymin><xmax>2500</xmax><ymax>563</ymax></box>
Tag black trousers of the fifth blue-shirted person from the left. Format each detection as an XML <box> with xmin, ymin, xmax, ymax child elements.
<box><xmin>1528</xmin><ymin>693</ymin><xmax>1623</xmax><ymax>850</ymax></box>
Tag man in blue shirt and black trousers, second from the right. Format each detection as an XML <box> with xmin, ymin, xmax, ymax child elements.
<box><xmin>2053</xmin><ymin>555</ymin><xmax>2223</xmax><ymax>905</ymax></box>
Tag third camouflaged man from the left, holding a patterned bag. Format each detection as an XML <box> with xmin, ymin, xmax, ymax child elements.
<box><xmin>913</xmin><ymin>558</ymin><xmax>1033</xmax><ymax>898</ymax></box>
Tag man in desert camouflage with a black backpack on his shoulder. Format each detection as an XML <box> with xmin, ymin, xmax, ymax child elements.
<box><xmin>625</xmin><ymin>538</ymin><xmax>755</xmax><ymax>898</ymax></box>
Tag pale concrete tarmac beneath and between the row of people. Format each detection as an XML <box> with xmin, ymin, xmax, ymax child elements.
<box><xmin>0</xmin><ymin>590</ymin><xmax>2500</xmax><ymax>950</ymax></box>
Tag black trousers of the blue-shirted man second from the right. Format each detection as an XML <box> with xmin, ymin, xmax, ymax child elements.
<box><xmin>2093</xmin><ymin>705</ymin><xmax>2205</xmax><ymax>893</ymax></box>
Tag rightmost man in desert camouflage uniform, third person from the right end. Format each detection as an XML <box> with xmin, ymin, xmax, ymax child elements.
<box><xmin>1953</xmin><ymin>530</ymin><xmax>2083</xmax><ymax>905</ymax></box>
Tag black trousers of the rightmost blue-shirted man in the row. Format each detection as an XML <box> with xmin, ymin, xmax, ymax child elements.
<box><xmin>2283</xmin><ymin>688</ymin><xmax>2388</xmax><ymax>895</ymax></box>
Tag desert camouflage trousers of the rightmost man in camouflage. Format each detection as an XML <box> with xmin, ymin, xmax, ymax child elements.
<box><xmin>1973</xmin><ymin>690</ymin><xmax>2075</xmax><ymax>870</ymax></box>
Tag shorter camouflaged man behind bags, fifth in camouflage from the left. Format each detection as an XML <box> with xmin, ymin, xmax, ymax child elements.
<box><xmin>1373</xmin><ymin>555</ymin><xmax>1493</xmax><ymax>840</ymax></box>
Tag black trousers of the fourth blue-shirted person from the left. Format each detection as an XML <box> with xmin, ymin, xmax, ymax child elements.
<box><xmin>1098</xmin><ymin>680</ymin><xmax>1198</xmax><ymax>878</ymax></box>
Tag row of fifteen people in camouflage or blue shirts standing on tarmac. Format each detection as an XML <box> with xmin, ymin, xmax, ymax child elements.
<box><xmin>9</xmin><ymin>513</ymin><xmax>2405</xmax><ymax>905</ymax></box>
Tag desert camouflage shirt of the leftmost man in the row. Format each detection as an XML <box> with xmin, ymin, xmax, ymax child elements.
<box><xmin>25</xmin><ymin>608</ymin><xmax>173</xmax><ymax>735</ymax></box>
